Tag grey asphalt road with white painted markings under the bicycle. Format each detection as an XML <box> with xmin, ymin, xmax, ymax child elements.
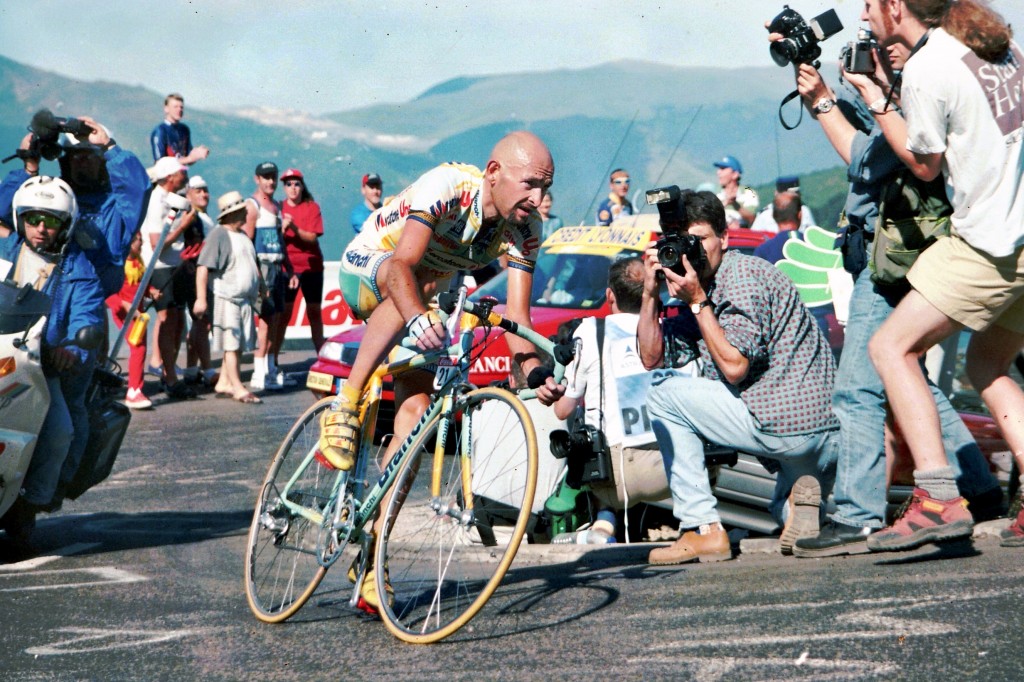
<box><xmin>0</xmin><ymin>353</ymin><xmax>1024</xmax><ymax>682</ymax></box>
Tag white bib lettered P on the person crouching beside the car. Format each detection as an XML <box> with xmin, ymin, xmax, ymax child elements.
<box><xmin>565</xmin><ymin>312</ymin><xmax>696</xmax><ymax>447</ymax></box>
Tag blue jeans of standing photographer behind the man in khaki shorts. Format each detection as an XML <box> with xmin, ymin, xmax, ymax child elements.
<box><xmin>833</xmin><ymin>269</ymin><xmax>998</xmax><ymax>528</ymax></box>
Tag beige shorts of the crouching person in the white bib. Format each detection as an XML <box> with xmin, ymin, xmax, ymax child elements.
<box><xmin>590</xmin><ymin>442</ymin><xmax>671</xmax><ymax>509</ymax></box>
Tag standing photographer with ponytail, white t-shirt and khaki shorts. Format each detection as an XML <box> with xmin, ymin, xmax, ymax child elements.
<box><xmin>850</xmin><ymin>0</ymin><xmax>1024</xmax><ymax>551</ymax></box>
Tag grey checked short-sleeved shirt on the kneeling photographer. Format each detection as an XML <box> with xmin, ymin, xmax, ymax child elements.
<box><xmin>663</xmin><ymin>251</ymin><xmax>839</xmax><ymax>435</ymax></box>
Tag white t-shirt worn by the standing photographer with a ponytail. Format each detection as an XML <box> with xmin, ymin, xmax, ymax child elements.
<box><xmin>902</xmin><ymin>29</ymin><xmax>1024</xmax><ymax>256</ymax></box>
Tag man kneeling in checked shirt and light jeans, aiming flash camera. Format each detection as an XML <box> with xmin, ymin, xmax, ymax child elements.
<box><xmin>637</xmin><ymin>187</ymin><xmax>839</xmax><ymax>564</ymax></box>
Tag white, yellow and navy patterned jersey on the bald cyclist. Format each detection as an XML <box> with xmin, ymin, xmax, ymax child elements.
<box><xmin>346</xmin><ymin>164</ymin><xmax>541</xmax><ymax>278</ymax></box>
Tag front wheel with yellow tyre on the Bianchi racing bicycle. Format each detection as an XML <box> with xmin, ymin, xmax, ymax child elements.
<box><xmin>375</xmin><ymin>388</ymin><xmax>537</xmax><ymax>644</ymax></box>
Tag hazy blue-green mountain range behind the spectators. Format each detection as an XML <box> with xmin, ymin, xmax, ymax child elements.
<box><xmin>0</xmin><ymin>56</ymin><xmax>846</xmax><ymax>258</ymax></box>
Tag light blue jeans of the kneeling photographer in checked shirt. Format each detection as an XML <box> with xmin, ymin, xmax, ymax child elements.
<box><xmin>647</xmin><ymin>377</ymin><xmax>836</xmax><ymax>528</ymax></box>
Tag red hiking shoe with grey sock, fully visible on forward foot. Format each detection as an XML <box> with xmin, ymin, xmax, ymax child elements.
<box><xmin>867</xmin><ymin>487</ymin><xmax>974</xmax><ymax>552</ymax></box>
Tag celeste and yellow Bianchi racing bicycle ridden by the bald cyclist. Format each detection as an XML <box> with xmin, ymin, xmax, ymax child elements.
<box><xmin>245</xmin><ymin>288</ymin><xmax>572</xmax><ymax>643</ymax></box>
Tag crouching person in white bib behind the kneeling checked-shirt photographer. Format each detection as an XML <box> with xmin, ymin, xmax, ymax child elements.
<box><xmin>552</xmin><ymin>257</ymin><xmax>696</xmax><ymax>545</ymax></box>
